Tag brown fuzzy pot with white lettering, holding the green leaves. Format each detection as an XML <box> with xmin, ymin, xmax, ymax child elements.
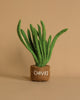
<box><xmin>30</xmin><ymin>65</ymin><xmax>50</xmax><ymax>81</ymax></box>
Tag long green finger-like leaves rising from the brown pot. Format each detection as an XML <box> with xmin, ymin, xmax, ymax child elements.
<box><xmin>17</xmin><ymin>20</ymin><xmax>68</xmax><ymax>81</ymax></box>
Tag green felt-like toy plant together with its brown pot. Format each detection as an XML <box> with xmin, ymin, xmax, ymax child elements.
<box><xmin>17</xmin><ymin>20</ymin><xmax>68</xmax><ymax>81</ymax></box>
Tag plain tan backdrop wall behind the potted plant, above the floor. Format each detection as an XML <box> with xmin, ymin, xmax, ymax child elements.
<box><xmin>0</xmin><ymin>0</ymin><xmax>80</xmax><ymax>77</ymax></box>
